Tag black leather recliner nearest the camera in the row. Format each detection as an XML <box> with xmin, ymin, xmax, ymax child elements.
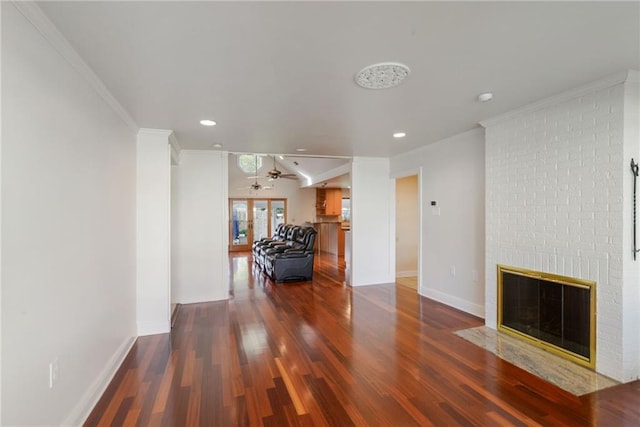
<box><xmin>263</xmin><ymin>227</ymin><xmax>317</xmax><ymax>282</ymax></box>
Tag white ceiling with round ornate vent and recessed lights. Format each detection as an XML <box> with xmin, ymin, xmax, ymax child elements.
<box><xmin>38</xmin><ymin>1</ymin><xmax>640</xmax><ymax>157</ymax></box>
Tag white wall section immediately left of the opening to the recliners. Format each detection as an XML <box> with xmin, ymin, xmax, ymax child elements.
<box><xmin>171</xmin><ymin>150</ymin><xmax>229</xmax><ymax>304</ymax></box>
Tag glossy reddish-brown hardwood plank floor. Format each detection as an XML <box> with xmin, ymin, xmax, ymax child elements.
<box><xmin>86</xmin><ymin>253</ymin><xmax>640</xmax><ymax>426</ymax></box>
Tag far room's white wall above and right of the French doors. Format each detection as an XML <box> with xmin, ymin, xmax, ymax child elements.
<box><xmin>229</xmin><ymin>154</ymin><xmax>316</xmax><ymax>224</ymax></box>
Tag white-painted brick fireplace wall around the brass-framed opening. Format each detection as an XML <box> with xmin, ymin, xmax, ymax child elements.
<box><xmin>482</xmin><ymin>71</ymin><xmax>640</xmax><ymax>382</ymax></box>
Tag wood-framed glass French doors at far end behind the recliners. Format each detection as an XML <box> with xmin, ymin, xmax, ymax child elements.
<box><xmin>229</xmin><ymin>199</ymin><xmax>287</xmax><ymax>252</ymax></box>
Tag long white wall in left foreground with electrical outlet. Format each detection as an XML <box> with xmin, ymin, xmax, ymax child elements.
<box><xmin>1</xmin><ymin>2</ymin><xmax>136</xmax><ymax>426</ymax></box>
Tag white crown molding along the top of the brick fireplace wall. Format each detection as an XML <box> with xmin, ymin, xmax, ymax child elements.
<box><xmin>478</xmin><ymin>70</ymin><xmax>640</xmax><ymax>128</ymax></box>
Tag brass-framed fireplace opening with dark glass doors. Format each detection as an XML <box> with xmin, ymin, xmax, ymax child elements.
<box><xmin>498</xmin><ymin>265</ymin><xmax>595</xmax><ymax>369</ymax></box>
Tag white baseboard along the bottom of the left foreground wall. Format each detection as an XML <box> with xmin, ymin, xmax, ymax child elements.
<box><xmin>62</xmin><ymin>337</ymin><xmax>136</xmax><ymax>426</ymax></box>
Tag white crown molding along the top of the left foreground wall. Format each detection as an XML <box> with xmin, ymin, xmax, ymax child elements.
<box><xmin>12</xmin><ymin>0</ymin><xmax>140</xmax><ymax>131</ymax></box>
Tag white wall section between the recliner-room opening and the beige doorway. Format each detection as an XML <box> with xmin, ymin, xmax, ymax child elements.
<box><xmin>349</xmin><ymin>157</ymin><xmax>395</xmax><ymax>286</ymax></box>
